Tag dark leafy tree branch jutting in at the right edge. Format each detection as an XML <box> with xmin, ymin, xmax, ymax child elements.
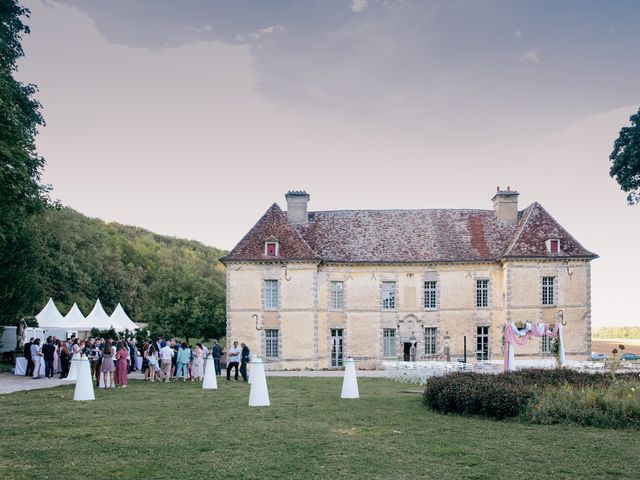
<box><xmin>609</xmin><ymin>109</ymin><xmax>640</xmax><ymax>205</ymax></box>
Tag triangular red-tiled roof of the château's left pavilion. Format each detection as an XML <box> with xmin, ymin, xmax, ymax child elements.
<box><xmin>220</xmin><ymin>203</ymin><xmax>320</xmax><ymax>262</ymax></box>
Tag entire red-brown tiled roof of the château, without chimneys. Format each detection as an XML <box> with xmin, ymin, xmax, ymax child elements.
<box><xmin>222</xmin><ymin>203</ymin><xmax>596</xmax><ymax>263</ymax></box>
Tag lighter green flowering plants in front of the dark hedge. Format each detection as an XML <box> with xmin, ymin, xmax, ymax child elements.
<box><xmin>522</xmin><ymin>381</ymin><xmax>640</xmax><ymax>428</ymax></box>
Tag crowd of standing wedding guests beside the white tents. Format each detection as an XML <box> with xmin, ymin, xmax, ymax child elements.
<box><xmin>24</xmin><ymin>336</ymin><xmax>251</xmax><ymax>388</ymax></box>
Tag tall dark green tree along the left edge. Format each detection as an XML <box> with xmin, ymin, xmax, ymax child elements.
<box><xmin>0</xmin><ymin>0</ymin><xmax>48</xmax><ymax>324</ymax></box>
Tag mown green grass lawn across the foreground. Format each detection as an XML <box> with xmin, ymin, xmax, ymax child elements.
<box><xmin>0</xmin><ymin>377</ymin><xmax>640</xmax><ymax>480</ymax></box>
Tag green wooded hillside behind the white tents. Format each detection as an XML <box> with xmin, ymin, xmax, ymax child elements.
<box><xmin>2</xmin><ymin>208</ymin><xmax>226</xmax><ymax>338</ymax></box>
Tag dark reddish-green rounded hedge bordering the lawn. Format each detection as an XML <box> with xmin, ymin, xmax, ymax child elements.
<box><xmin>423</xmin><ymin>369</ymin><xmax>637</xmax><ymax>419</ymax></box>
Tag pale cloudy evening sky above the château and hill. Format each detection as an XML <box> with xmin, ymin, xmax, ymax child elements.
<box><xmin>13</xmin><ymin>0</ymin><xmax>640</xmax><ymax>326</ymax></box>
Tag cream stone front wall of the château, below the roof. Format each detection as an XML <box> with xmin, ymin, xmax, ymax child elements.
<box><xmin>227</xmin><ymin>260</ymin><xmax>591</xmax><ymax>369</ymax></box>
